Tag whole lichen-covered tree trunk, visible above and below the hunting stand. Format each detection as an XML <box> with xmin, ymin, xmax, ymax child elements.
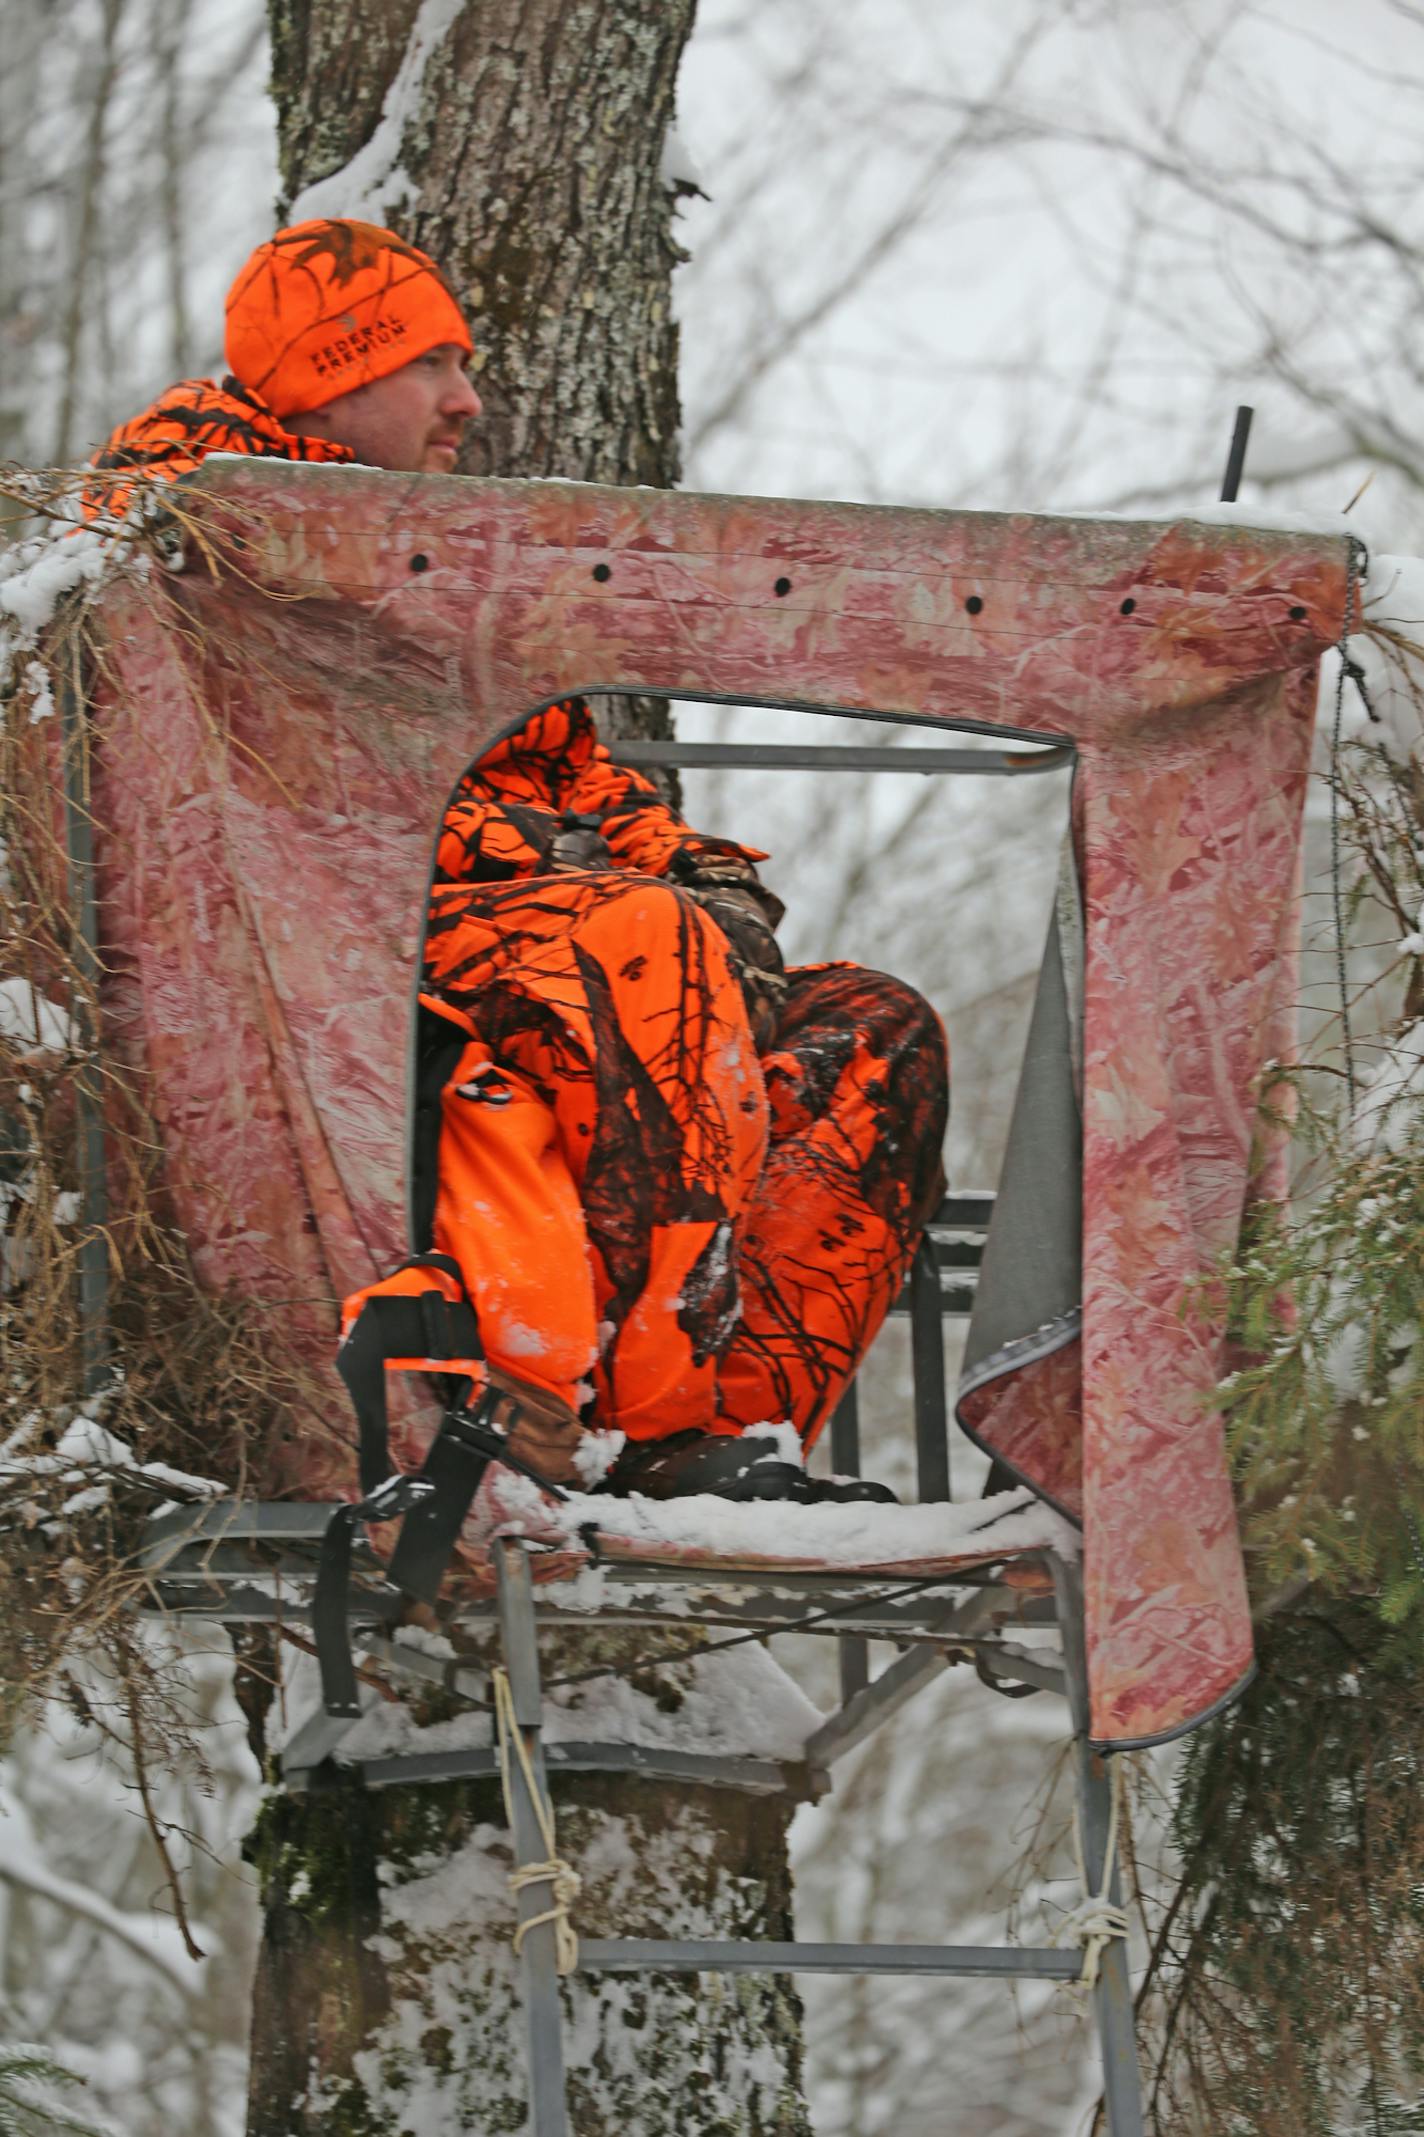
<box><xmin>248</xmin><ymin>0</ymin><xmax>808</xmax><ymax>2137</ymax></box>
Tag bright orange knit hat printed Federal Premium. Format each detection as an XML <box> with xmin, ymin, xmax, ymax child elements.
<box><xmin>227</xmin><ymin>216</ymin><xmax>475</xmax><ymax>417</ymax></box>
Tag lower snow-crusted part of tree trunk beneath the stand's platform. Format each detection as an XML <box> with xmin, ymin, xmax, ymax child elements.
<box><xmin>248</xmin><ymin>1776</ymin><xmax>810</xmax><ymax>2137</ymax></box>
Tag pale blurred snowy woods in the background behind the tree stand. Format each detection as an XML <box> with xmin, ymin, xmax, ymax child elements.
<box><xmin>0</xmin><ymin>0</ymin><xmax>1424</xmax><ymax>2137</ymax></box>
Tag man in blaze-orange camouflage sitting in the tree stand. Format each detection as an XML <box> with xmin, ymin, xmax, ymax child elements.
<box><xmin>94</xmin><ymin>218</ymin><xmax>949</xmax><ymax>1500</ymax></box>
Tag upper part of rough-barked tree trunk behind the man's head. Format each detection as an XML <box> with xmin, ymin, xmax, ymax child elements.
<box><xmin>267</xmin><ymin>0</ymin><xmax>697</xmax><ymax>760</ymax></box>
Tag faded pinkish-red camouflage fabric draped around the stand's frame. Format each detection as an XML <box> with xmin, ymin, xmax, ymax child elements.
<box><xmin>83</xmin><ymin>462</ymin><xmax>1351</xmax><ymax>1746</ymax></box>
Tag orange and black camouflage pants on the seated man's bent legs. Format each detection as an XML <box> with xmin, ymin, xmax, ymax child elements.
<box><xmin>423</xmin><ymin>870</ymin><xmax>947</xmax><ymax>1445</ymax></box>
